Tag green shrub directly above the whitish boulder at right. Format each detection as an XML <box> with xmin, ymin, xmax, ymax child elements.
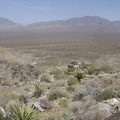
<box><xmin>96</xmin><ymin>88</ymin><xmax>114</xmax><ymax>101</ymax></box>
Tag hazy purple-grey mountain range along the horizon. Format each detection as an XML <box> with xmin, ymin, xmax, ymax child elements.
<box><xmin>0</xmin><ymin>16</ymin><xmax>120</xmax><ymax>33</ymax></box>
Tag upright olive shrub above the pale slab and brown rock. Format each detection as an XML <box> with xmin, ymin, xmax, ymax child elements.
<box><xmin>33</xmin><ymin>83</ymin><xmax>44</xmax><ymax>98</ymax></box>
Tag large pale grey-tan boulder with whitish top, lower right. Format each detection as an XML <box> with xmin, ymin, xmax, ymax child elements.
<box><xmin>73</xmin><ymin>98</ymin><xmax>120</xmax><ymax>120</ymax></box>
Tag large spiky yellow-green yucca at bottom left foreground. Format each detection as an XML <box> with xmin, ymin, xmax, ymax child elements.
<box><xmin>9</xmin><ymin>104</ymin><xmax>38</xmax><ymax>120</ymax></box>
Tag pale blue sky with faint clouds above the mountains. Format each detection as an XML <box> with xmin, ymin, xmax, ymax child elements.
<box><xmin>0</xmin><ymin>0</ymin><xmax>120</xmax><ymax>24</ymax></box>
